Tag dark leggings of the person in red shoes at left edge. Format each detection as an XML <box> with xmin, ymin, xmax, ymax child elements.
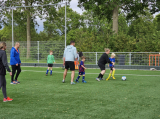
<box><xmin>0</xmin><ymin>75</ymin><xmax>7</xmax><ymax>98</ymax></box>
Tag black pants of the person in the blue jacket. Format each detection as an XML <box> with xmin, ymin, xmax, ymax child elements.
<box><xmin>11</xmin><ymin>64</ymin><xmax>21</xmax><ymax>81</ymax></box>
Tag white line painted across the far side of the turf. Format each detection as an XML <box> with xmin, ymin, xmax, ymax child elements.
<box><xmin>22</xmin><ymin>70</ymin><xmax>160</xmax><ymax>77</ymax></box>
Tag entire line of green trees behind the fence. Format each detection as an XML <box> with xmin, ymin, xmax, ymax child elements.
<box><xmin>0</xmin><ymin>0</ymin><xmax>160</xmax><ymax>57</ymax></box>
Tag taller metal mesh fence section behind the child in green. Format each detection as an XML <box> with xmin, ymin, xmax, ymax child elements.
<box><xmin>6</xmin><ymin>41</ymin><xmax>65</xmax><ymax>63</ymax></box>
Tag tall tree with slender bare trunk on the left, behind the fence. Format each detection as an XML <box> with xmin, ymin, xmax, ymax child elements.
<box><xmin>0</xmin><ymin>0</ymin><xmax>70</xmax><ymax>58</ymax></box>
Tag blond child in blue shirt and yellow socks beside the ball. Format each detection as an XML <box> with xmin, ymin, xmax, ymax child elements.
<box><xmin>106</xmin><ymin>53</ymin><xmax>116</xmax><ymax>81</ymax></box>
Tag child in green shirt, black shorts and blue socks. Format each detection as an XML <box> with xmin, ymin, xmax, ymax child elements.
<box><xmin>46</xmin><ymin>51</ymin><xmax>55</xmax><ymax>76</ymax></box>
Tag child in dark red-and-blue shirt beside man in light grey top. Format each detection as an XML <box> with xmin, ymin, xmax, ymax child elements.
<box><xmin>75</xmin><ymin>56</ymin><xmax>87</xmax><ymax>83</ymax></box>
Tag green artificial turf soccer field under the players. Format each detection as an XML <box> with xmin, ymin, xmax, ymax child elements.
<box><xmin>0</xmin><ymin>67</ymin><xmax>160</xmax><ymax>119</ymax></box>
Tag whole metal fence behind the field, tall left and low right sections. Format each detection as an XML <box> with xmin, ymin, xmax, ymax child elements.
<box><xmin>6</xmin><ymin>41</ymin><xmax>160</xmax><ymax>66</ymax></box>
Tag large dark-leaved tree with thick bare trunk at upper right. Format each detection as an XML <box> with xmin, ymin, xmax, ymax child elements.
<box><xmin>79</xmin><ymin>0</ymin><xmax>158</xmax><ymax>33</ymax></box>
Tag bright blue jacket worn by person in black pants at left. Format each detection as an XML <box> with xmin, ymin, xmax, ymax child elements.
<box><xmin>10</xmin><ymin>47</ymin><xmax>21</xmax><ymax>65</ymax></box>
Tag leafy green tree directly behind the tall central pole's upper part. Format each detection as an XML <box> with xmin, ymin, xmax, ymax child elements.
<box><xmin>44</xmin><ymin>6</ymin><xmax>83</xmax><ymax>37</ymax></box>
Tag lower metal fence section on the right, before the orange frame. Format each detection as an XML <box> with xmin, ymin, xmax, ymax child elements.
<box><xmin>83</xmin><ymin>52</ymin><xmax>160</xmax><ymax>66</ymax></box>
